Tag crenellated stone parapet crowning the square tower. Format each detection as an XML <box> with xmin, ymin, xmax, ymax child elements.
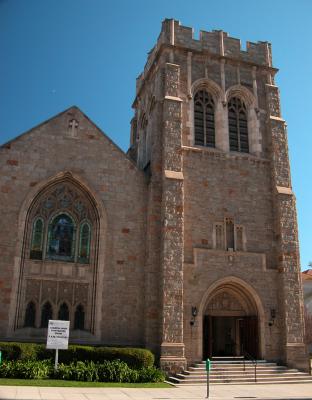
<box><xmin>136</xmin><ymin>19</ymin><xmax>277</xmax><ymax>101</ymax></box>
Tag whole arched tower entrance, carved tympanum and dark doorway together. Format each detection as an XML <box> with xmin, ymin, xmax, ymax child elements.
<box><xmin>203</xmin><ymin>282</ymin><xmax>259</xmax><ymax>359</ymax></box>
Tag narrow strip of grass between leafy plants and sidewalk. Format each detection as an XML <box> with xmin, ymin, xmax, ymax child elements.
<box><xmin>0</xmin><ymin>378</ymin><xmax>172</xmax><ymax>388</ymax></box>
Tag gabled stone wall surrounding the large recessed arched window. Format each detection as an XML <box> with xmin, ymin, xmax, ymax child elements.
<box><xmin>0</xmin><ymin>108</ymin><xmax>146</xmax><ymax>344</ymax></box>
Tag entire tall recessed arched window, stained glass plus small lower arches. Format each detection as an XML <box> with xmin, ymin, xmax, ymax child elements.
<box><xmin>14</xmin><ymin>180</ymin><xmax>98</xmax><ymax>337</ymax></box>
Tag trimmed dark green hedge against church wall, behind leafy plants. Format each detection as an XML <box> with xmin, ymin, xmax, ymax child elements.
<box><xmin>0</xmin><ymin>342</ymin><xmax>154</xmax><ymax>369</ymax></box>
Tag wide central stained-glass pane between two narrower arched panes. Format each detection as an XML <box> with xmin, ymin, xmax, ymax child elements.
<box><xmin>47</xmin><ymin>213</ymin><xmax>76</xmax><ymax>261</ymax></box>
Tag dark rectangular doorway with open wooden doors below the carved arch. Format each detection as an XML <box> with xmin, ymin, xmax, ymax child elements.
<box><xmin>203</xmin><ymin>315</ymin><xmax>259</xmax><ymax>359</ymax></box>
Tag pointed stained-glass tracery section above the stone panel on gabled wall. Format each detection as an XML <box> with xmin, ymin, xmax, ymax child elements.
<box><xmin>29</xmin><ymin>185</ymin><xmax>92</xmax><ymax>264</ymax></box>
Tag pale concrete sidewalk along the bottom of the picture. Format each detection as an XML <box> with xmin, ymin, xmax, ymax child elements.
<box><xmin>0</xmin><ymin>383</ymin><xmax>312</xmax><ymax>400</ymax></box>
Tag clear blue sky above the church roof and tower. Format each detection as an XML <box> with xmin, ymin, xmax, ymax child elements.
<box><xmin>0</xmin><ymin>0</ymin><xmax>312</xmax><ymax>269</ymax></box>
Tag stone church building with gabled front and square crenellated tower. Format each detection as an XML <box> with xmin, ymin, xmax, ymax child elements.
<box><xmin>0</xmin><ymin>20</ymin><xmax>307</xmax><ymax>370</ymax></box>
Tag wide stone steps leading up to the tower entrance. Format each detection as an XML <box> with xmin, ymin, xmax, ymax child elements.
<box><xmin>169</xmin><ymin>357</ymin><xmax>312</xmax><ymax>385</ymax></box>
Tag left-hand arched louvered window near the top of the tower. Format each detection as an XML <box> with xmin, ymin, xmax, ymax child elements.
<box><xmin>194</xmin><ymin>90</ymin><xmax>215</xmax><ymax>147</ymax></box>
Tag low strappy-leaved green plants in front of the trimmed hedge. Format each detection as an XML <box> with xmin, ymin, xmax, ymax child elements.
<box><xmin>0</xmin><ymin>360</ymin><xmax>165</xmax><ymax>383</ymax></box>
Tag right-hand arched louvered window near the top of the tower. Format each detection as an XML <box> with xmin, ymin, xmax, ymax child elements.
<box><xmin>228</xmin><ymin>97</ymin><xmax>249</xmax><ymax>153</ymax></box>
